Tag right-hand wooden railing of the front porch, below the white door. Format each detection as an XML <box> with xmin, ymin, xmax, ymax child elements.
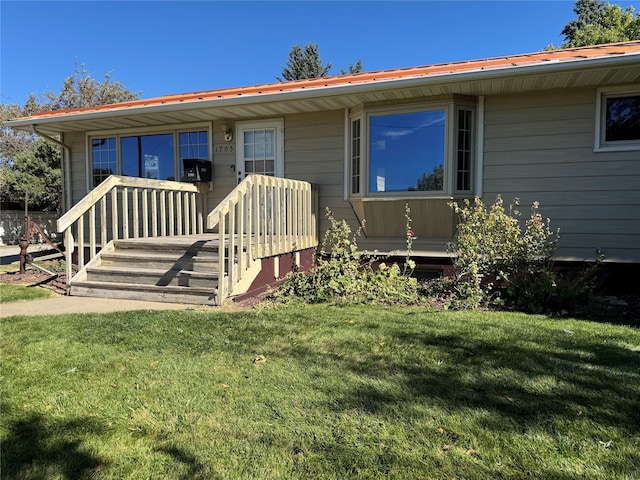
<box><xmin>207</xmin><ymin>175</ymin><xmax>318</xmax><ymax>302</ymax></box>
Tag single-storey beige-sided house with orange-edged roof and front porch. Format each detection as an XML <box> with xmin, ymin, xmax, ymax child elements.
<box><xmin>8</xmin><ymin>41</ymin><xmax>640</xmax><ymax>303</ymax></box>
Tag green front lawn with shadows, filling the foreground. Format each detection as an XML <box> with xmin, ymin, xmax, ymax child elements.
<box><xmin>0</xmin><ymin>305</ymin><xmax>640</xmax><ymax>480</ymax></box>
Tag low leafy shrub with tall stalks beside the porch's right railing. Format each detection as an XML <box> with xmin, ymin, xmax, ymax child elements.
<box><xmin>273</xmin><ymin>207</ymin><xmax>420</xmax><ymax>305</ymax></box>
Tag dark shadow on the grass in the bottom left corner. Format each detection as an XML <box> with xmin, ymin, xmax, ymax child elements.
<box><xmin>0</xmin><ymin>414</ymin><xmax>104</xmax><ymax>480</ymax></box>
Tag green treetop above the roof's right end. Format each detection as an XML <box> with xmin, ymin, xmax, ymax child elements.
<box><xmin>562</xmin><ymin>0</ymin><xmax>640</xmax><ymax>48</ymax></box>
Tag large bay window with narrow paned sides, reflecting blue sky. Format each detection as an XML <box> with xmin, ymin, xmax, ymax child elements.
<box><xmin>349</xmin><ymin>101</ymin><xmax>474</xmax><ymax>196</ymax></box>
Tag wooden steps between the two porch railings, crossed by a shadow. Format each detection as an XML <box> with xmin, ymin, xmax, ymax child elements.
<box><xmin>69</xmin><ymin>235</ymin><xmax>228</xmax><ymax>305</ymax></box>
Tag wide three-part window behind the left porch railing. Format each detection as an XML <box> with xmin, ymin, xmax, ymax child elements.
<box><xmin>91</xmin><ymin>130</ymin><xmax>209</xmax><ymax>187</ymax></box>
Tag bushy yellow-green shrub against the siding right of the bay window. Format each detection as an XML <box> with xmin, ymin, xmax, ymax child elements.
<box><xmin>449</xmin><ymin>196</ymin><xmax>599</xmax><ymax>312</ymax></box>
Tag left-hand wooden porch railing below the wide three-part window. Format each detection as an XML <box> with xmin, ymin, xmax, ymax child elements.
<box><xmin>57</xmin><ymin>175</ymin><xmax>203</xmax><ymax>284</ymax></box>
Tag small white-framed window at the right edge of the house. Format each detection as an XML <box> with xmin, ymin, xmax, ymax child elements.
<box><xmin>595</xmin><ymin>90</ymin><xmax>640</xmax><ymax>150</ymax></box>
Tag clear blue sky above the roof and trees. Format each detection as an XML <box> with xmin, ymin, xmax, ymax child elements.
<box><xmin>0</xmin><ymin>0</ymin><xmax>638</xmax><ymax>104</ymax></box>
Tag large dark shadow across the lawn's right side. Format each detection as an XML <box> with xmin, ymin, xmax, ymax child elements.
<box><xmin>292</xmin><ymin>322</ymin><xmax>640</xmax><ymax>436</ymax></box>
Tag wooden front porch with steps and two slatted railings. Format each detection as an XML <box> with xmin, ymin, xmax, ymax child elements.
<box><xmin>58</xmin><ymin>175</ymin><xmax>318</xmax><ymax>305</ymax></box>
